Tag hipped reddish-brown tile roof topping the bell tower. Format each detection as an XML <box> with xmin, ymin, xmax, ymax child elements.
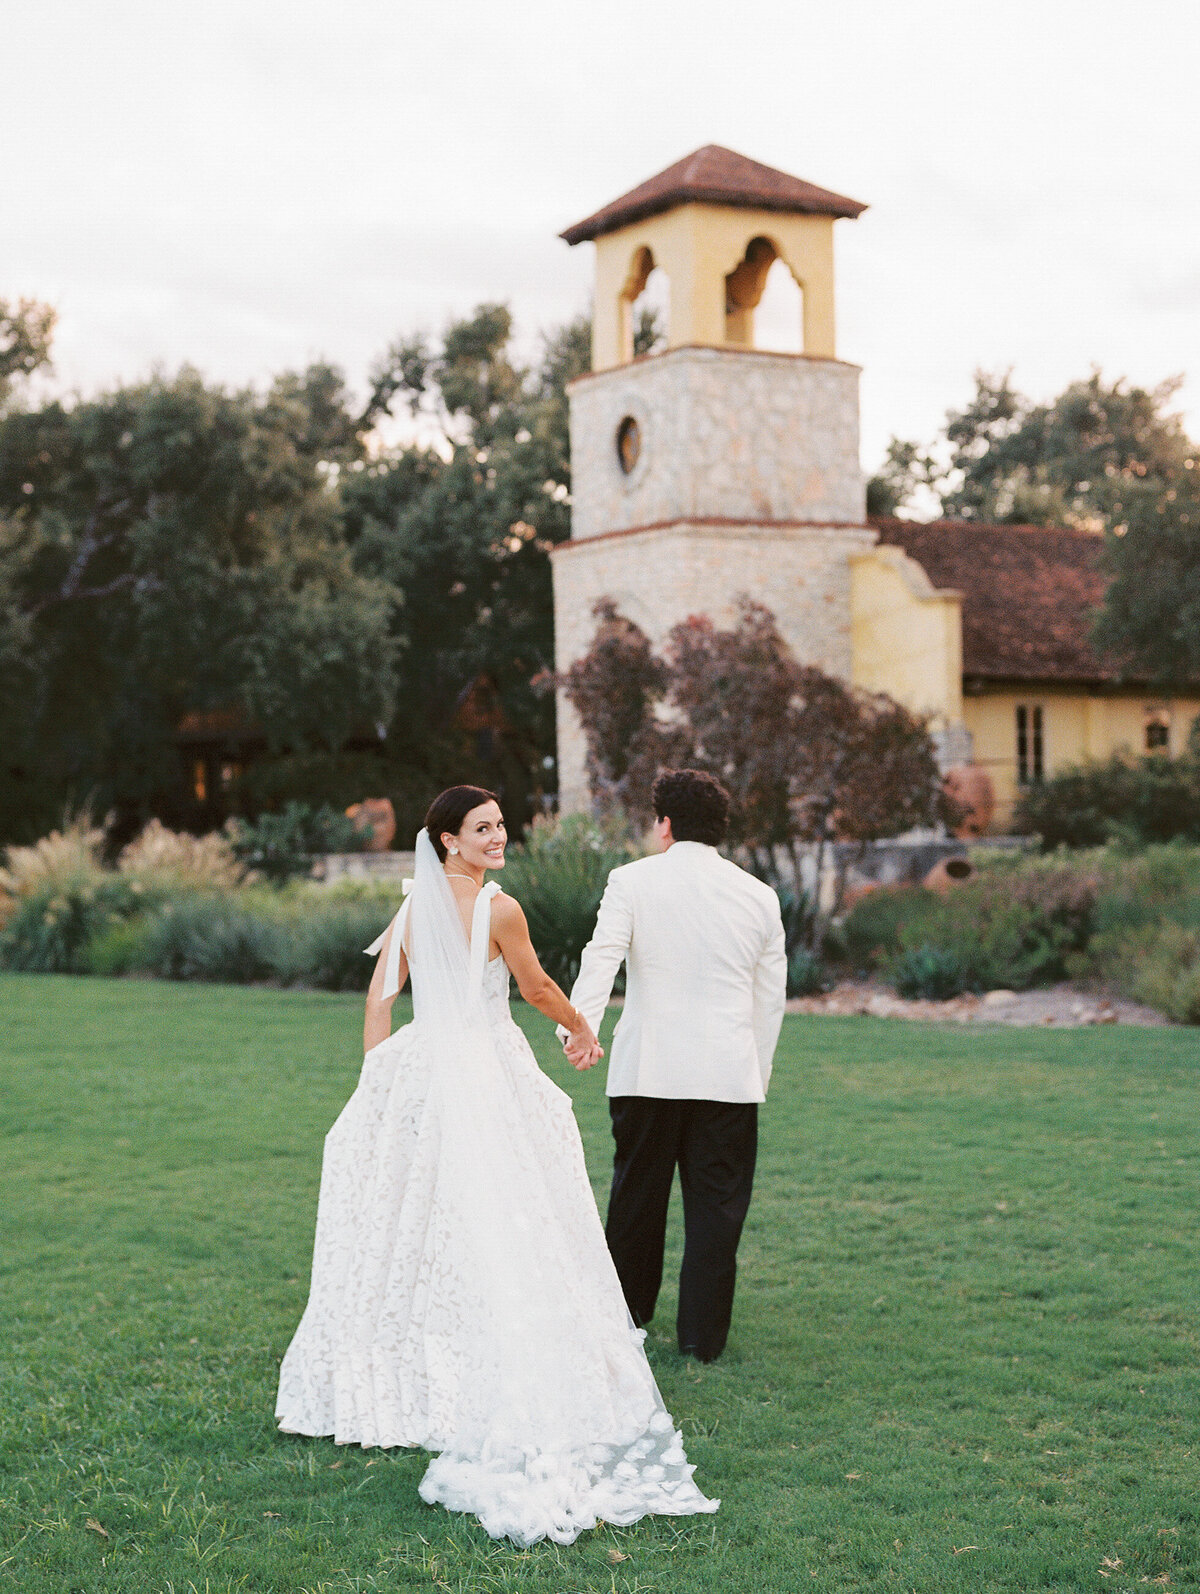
<box><xmin>559</xmin><ymin>143</ymin><xmax>867</xmax><ymax>244</ymax></box>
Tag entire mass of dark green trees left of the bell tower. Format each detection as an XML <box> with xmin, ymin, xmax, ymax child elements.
<box><xmin>0</xmin><ymin>304</ymin><xmax>657</xmax><ymax>838</ymax></box>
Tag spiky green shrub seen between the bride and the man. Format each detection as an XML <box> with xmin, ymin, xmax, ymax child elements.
<box><xmin>502</xmin><ymin>815</ymin><xmax>637</xmax><ymax>990</ymax></box>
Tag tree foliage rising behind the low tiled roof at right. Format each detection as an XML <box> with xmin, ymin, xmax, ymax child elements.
<box><xmin>867</xmin><ymin>371</ymin><xmax>1200</xmax><ymax>682</ymax></box>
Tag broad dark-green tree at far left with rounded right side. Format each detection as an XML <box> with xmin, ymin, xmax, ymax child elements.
<box><xmin>0</xmin><ymin>365</ymin><xmax>395</xmax><ymax>834</ymax></box>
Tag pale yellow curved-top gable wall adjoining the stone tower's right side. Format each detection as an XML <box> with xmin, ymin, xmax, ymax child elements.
<box><xmin>849</xmin><ymin>547</ymin><xmax>963</xmax><ymax>730</ymax></box>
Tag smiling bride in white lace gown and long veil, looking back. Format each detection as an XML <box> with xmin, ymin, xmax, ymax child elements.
<box><xmin>276</xmin><ymin>786</ymin><xmax>719</xmax><ymax>1545</ymax></box>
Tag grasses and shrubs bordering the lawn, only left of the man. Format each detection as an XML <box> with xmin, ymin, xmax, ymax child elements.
<box><xmin>0</xmin><ymin>819</ymin><xmax>636</xmax><ymax>990</ymax></box>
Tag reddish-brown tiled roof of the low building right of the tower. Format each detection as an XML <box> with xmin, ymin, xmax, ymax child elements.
<box><xmin>872</xmin><ymin>518</ymin><xmax>1133</xmax><ymax>684</ymax></box>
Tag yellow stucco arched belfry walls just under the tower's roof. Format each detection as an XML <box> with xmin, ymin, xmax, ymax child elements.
<box><xmin>591</xmin><ymin>204</ymin><xmax>837</xmax><ymax>371</ymax></box>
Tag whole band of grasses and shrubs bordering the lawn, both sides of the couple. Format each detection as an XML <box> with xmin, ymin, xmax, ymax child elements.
<box><xmin>0</xmin><ymin>818</ymin><xmax>1200</xmax><ymax>1023</ymax></box>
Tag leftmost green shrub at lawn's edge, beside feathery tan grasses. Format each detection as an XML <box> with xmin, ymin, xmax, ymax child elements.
<box><xmin>0</xmin><ymin>870</ymin><xmax>145</xmax><ymax>974</ymax></box>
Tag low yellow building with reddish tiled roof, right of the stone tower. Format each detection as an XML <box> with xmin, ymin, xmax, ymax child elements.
<box><xmin>851</xmin><ymin>520</ymin><xmax>1200</xmax><ymax>830</ymax></box>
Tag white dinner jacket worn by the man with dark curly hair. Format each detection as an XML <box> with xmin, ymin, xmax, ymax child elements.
<box><xmin>571</xmin><ymin>842</ymin><xmax>787</xmax><ymax>1101</ymax></box>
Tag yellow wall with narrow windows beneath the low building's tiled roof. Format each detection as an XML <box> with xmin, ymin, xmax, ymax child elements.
<box><xmin>963</xmin><ymin>684</ymin><xmax>1200</xmax><ymax>830</ymax></box>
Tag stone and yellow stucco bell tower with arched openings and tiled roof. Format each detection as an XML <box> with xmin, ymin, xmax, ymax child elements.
<box><xmin>553</xmin><ymin>145</ymin><xmax>875</xmax><ymax>813</ymax></box>
